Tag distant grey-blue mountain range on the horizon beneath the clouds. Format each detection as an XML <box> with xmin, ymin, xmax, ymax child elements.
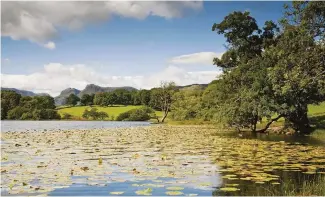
<box><xmin>1</xmin><ymin>84</ymin><xmax>208</xmax><ymax>106</ymax></box>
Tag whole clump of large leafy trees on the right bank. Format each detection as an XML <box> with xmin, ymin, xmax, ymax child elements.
<box><xmin>205</xmin><ymin>2</ymin><xmax>325</xmax><ymax>133</ymax></box>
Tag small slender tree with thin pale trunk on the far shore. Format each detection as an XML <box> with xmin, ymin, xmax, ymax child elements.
<box><xmin>150</xmin><ymin>82</ymin><xmax>175</xmax><ymax>122</ymax></box>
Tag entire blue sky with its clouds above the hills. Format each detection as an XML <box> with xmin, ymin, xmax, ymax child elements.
<box><xmin>1</xmin><ymin>1</ymin><xmax>284</xmax><ymax>96</ymax></box>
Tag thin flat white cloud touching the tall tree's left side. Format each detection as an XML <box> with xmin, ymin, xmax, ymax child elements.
<box><xmin>169</xmin><ymin>52</ymin><xmax>222</xmax><ymax>65</ymax></box>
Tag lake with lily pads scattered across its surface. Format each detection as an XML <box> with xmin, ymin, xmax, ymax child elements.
<box><xmin>1</xmin><ymin>121</ymin><xmax>325</xmax><ymax>196</ymax></box>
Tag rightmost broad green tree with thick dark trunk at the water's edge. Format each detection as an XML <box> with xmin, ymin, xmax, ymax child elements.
<box><xmin>264</xmin><ymin>26</ymin><xmax>325</xmax><ymax>133</ymax></box>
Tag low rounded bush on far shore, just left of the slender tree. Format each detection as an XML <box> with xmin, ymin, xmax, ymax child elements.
<box><xmin>116</xmin><ymin>107</ymin><xmax>154</xmax><ymax>121</ymax></box>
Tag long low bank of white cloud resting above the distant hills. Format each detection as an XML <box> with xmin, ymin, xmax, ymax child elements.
<box><xmin>1</xmin><ymin>63</ymin><xmax>221</xmax><ymax>96</ymax></box>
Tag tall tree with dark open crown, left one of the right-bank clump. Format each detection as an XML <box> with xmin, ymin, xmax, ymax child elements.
<box><xmin>210</xmin><ymin>12</ymin><xmax>278</xmax><ymax>132</ymax></box>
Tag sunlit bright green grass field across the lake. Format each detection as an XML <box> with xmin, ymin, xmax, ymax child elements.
<box><xmin>58</xmin><ymin>105</ymin><xmax>162</xmax><ymax>120</ymax></box>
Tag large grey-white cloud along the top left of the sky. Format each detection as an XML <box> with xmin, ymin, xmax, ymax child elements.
<box><xmin>1</xmin><ymin>1</ymin><xmax>203</xmax><ymax>49</ymax></box>
